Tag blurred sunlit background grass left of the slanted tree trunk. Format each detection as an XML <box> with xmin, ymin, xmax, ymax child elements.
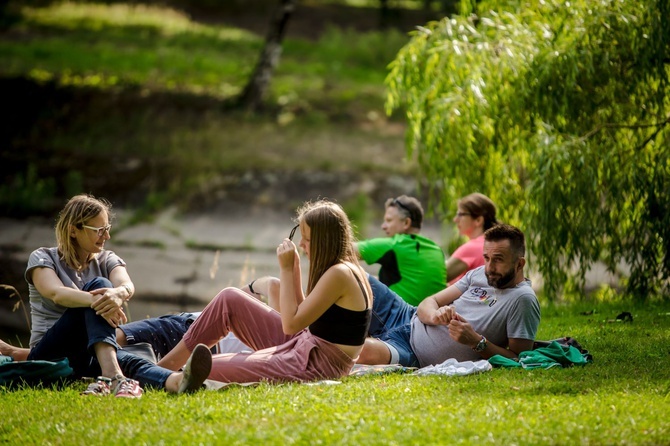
<box><xmin>0</xmin><ymin>3</ymin><xmax>261</xmax><ymax>98</ymax></box>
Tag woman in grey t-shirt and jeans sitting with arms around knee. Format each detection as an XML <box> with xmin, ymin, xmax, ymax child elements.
<box><xmin>25</xmin><ymin>194</ymin><xmax>211</xmax><ymax>398</ymax></box>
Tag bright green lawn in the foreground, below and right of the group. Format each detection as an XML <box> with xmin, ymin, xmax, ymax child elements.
<box><xmin>0</xmin><ymin>303</ymin><xmax>670</xmax><ymax>445</ymax></box>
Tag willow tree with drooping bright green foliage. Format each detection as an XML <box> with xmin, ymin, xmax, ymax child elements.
<box><xmin>387</xmin><ymin>0</ymin><xmax>670</xmax><ymax>299</ymax></box>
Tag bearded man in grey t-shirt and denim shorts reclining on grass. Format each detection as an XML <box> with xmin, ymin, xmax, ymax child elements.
<box><xmin>358</xmin><ymin>224</ymin><xmax>540</xmax><ymax>367</ymax></box>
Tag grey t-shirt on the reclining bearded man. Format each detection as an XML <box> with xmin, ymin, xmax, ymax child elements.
<box><xmin>410</xmin><ymin>266</ymin><xmax>540</xmax><ymax>367</ymax></box>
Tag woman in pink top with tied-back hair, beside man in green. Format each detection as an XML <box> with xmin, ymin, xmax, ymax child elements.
<box><xmin>445</xmin><ymin>193</ymin><xmax>498</xmax><ymax>285</ymax></box>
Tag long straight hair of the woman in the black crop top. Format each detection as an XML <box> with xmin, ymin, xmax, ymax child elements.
<box><xmin>298</xmin><ymin>200</ymin><xmax>359</xmax><ymax>294</ymax></box>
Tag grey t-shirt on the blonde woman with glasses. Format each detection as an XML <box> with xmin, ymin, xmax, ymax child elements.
<box><xmin>25</xmin><ymin>247</ymin><xmax>126</xmax><ymax>347</ymax></box>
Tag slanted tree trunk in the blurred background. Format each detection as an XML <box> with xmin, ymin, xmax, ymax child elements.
<box><xmin>239</xmin><ymin>0</ymin><xmax>297</xmax><ymax>112</ymax></box>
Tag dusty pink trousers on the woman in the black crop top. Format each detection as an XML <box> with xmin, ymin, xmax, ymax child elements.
<box><xmin>183</xmin><ymin>288</ymin><xmax>354</xmax><ymax>383</ymax></box>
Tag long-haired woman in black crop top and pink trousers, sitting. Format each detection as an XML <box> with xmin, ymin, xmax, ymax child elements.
<box><xmin>159</xmin><ymin>200</ymin><xmax>372</xmax><ymax>383</ymax></box>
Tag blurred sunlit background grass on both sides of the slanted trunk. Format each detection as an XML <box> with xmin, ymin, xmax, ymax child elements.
<box><xmin>0</xmin><ymin>2</ymin><xmax>407</xmax><ymax>102</ymax></box>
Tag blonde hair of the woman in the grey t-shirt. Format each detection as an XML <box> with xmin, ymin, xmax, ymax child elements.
<box><xmin>56</xmin><ymin>194</ymin><xmax>113</xmax><ymax>271</ymax></box>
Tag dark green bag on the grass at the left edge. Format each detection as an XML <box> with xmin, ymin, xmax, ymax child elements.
<box><xmin>0</xmin><ymin>355</ymin><xmax>73</xmax><ymax>386</ymax></box>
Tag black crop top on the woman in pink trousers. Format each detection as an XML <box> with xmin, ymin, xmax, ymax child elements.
<box><xmin>309</xmin><ymin>268</ymin><xmax>372</xmax><ymax>345</ymax></box>
